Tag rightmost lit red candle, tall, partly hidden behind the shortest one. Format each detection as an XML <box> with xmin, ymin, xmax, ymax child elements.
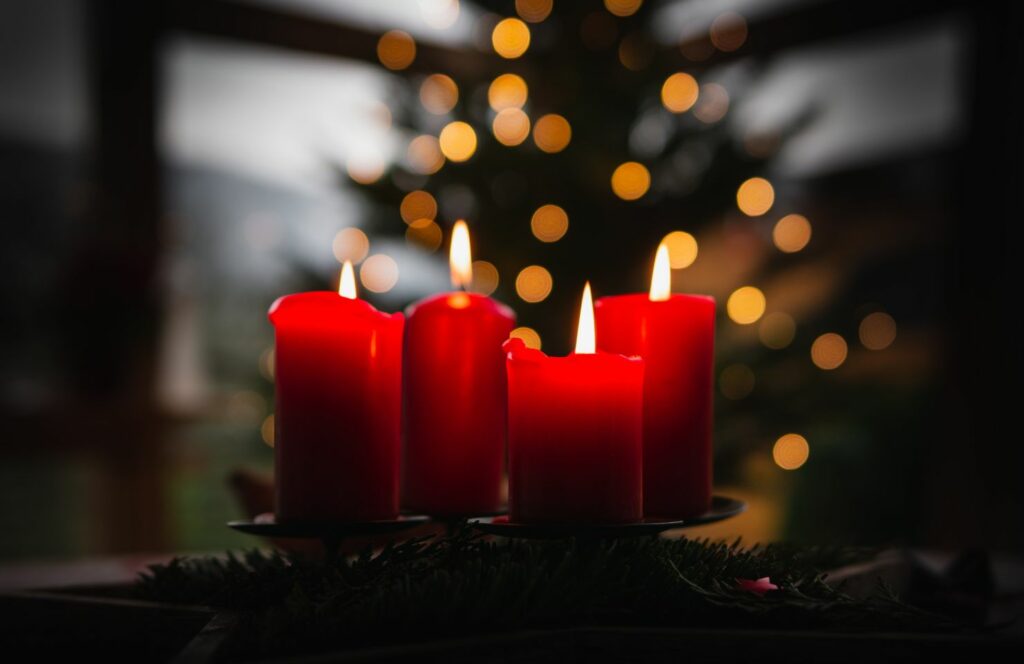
<box><xmin>597</xmin><ymin>244</ymin><xmax>715</xmax><ymax>517</ymax></box>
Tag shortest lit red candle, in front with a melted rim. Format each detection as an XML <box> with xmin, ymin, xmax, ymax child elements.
<box><xmin>505</xmin><ymin>284</ymin><xmax>644</xmax><ymax>524</ymax></box>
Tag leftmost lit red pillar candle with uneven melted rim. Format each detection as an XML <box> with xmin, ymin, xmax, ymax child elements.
<box><xmin>268</xmin><ymin>262</ymin><xmax>404</xmax><ymax>521</ymax></box>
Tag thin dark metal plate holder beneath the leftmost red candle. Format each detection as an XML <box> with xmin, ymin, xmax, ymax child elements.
<box><xmin>227</xmin><ymin>513</ymin><xmax>430</xmax><ymax>558</ymax></box>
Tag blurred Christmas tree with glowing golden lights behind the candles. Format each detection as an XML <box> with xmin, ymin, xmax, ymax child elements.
<box><xmin>336</xmin><ymin>0</ymin><xmax>942</xmax><ymax>539</ymax></box>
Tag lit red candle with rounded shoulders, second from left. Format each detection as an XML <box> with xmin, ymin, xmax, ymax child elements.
<box><xmin>402</xmin><ymin>221</ymin><xmax>515</xmax><ymax>515</ymax></box>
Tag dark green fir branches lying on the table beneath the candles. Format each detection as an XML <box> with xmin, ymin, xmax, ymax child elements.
<box><xmin>137</xmin><ymin>529</ymin><xmax>948</xmax><ymax>654</ymax></box>
